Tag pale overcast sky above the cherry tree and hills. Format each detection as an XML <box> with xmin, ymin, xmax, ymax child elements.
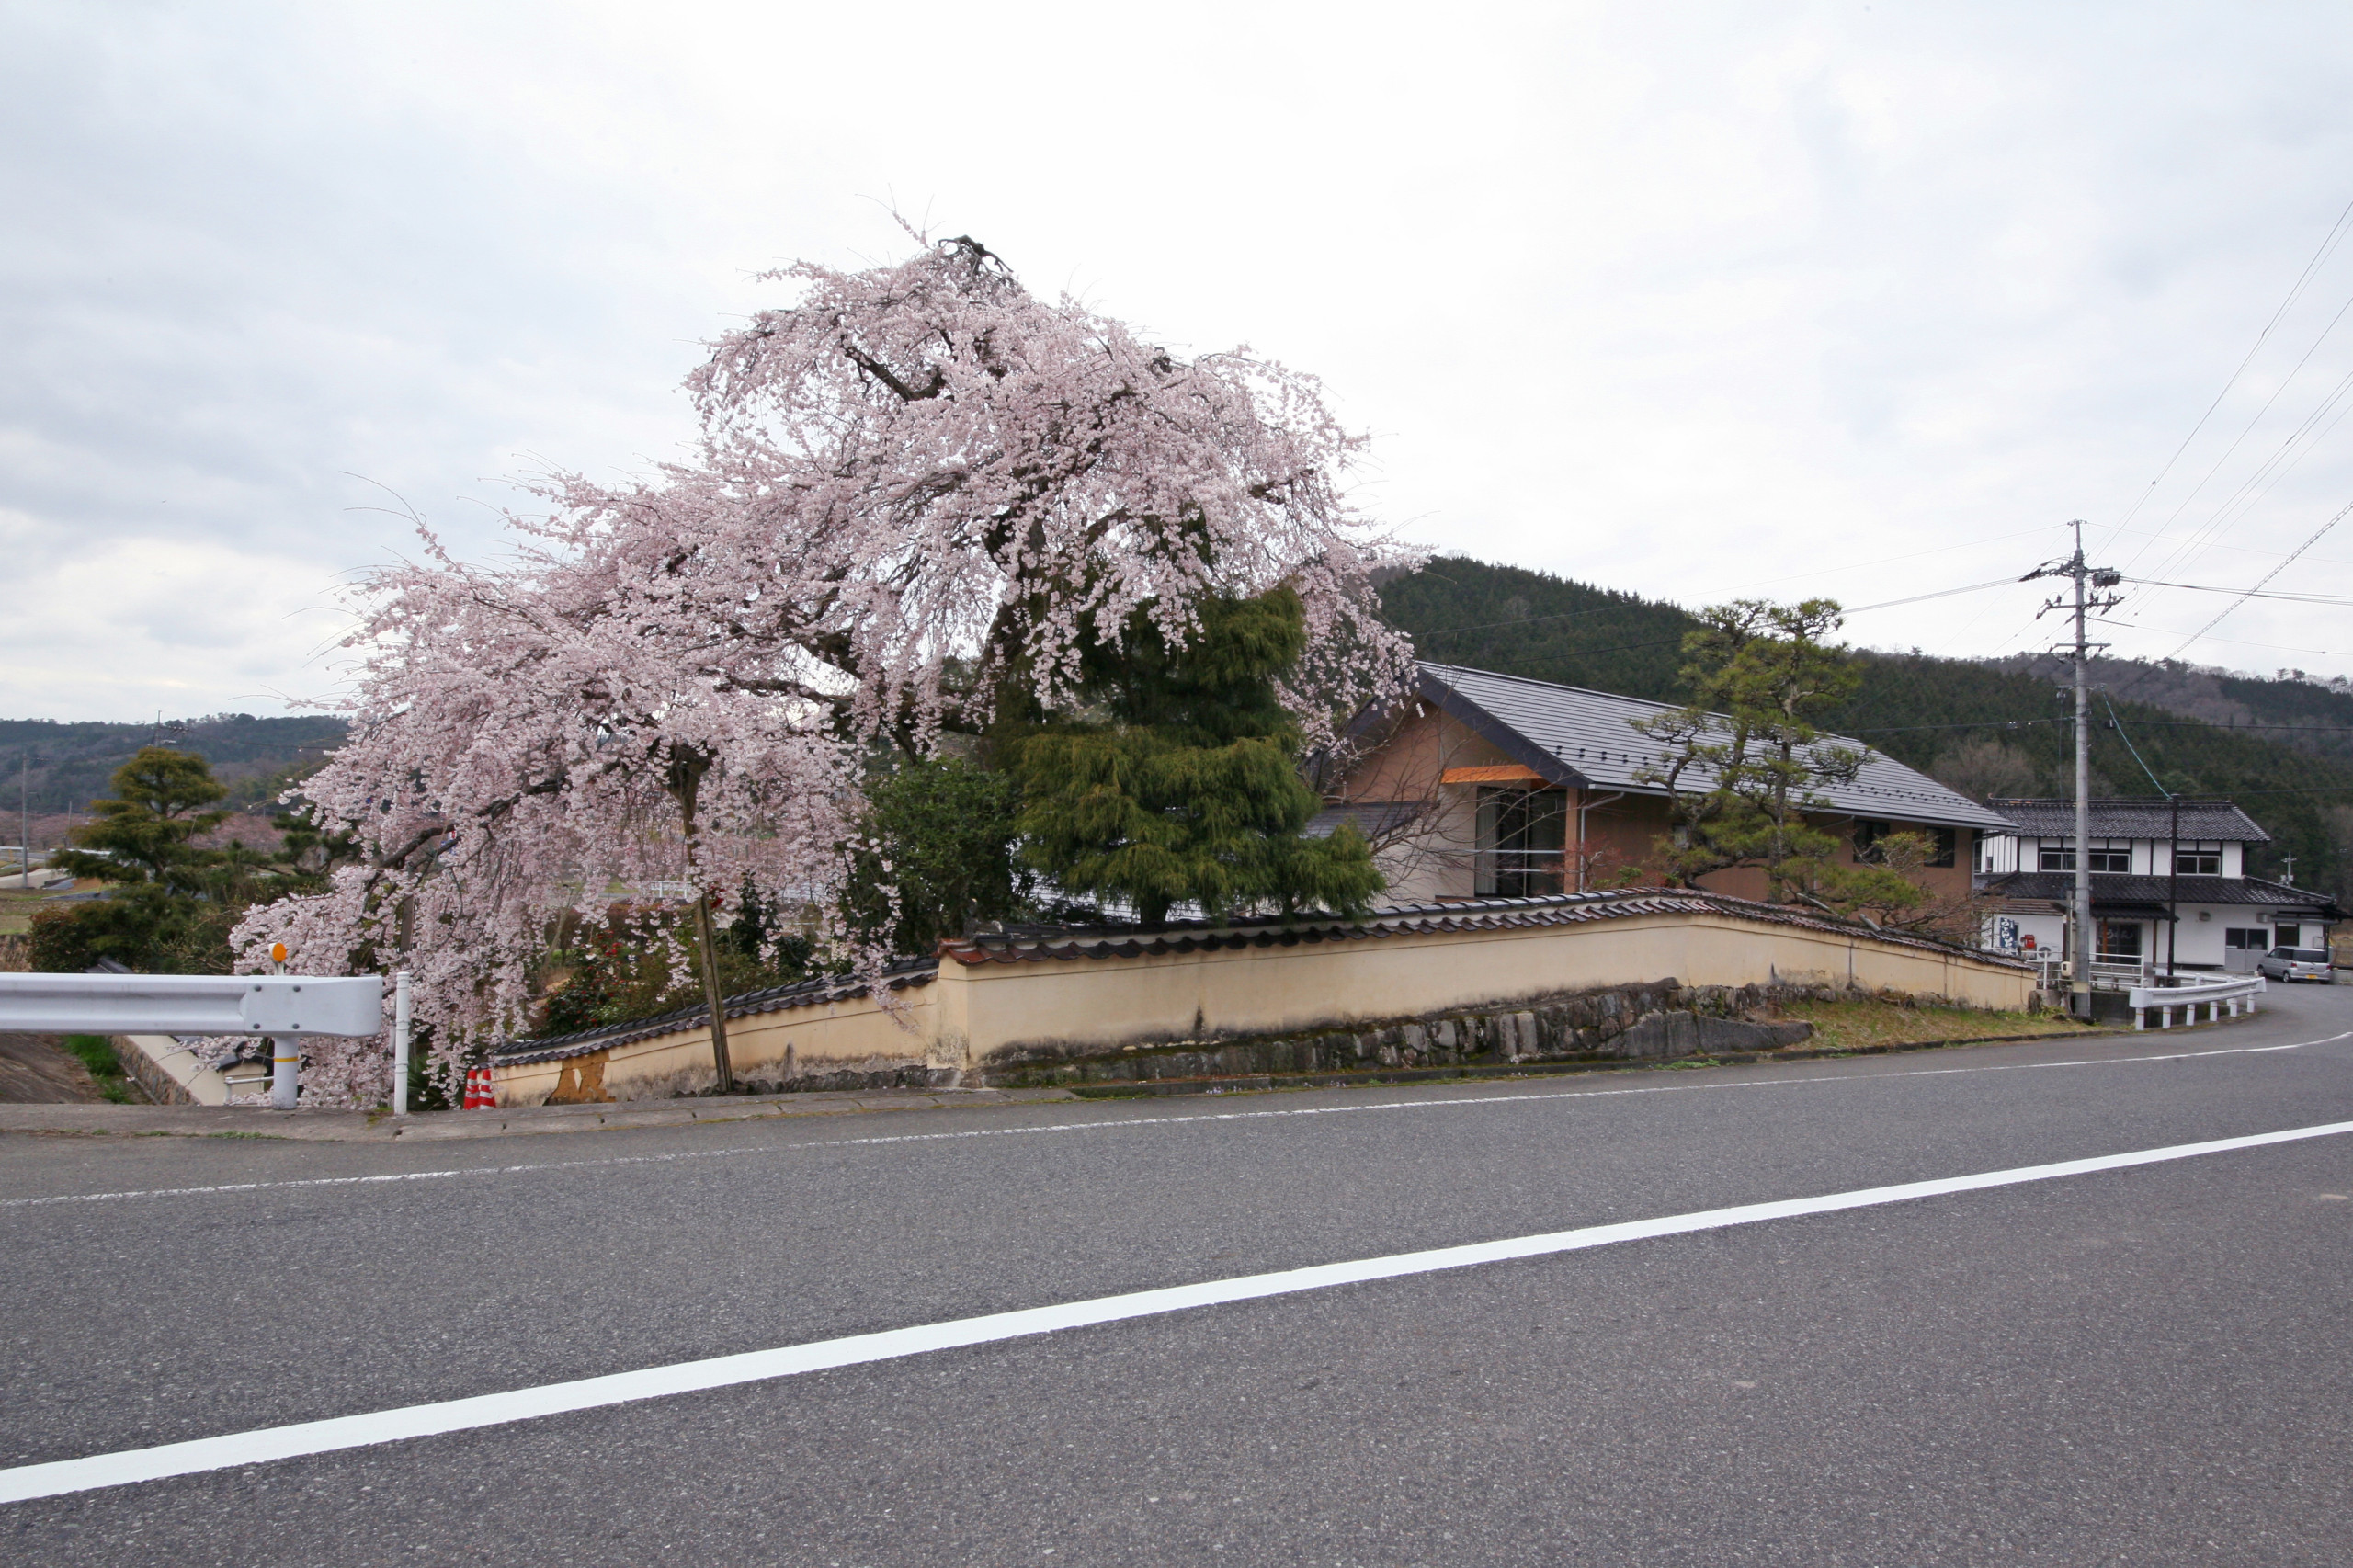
<box><xmin>0</xmin><ymin>0</ymin><xmax>2353</xmax><ymax>718</ymax></box>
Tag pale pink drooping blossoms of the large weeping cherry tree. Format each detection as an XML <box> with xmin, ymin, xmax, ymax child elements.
<box><xmin>240</xmin><ymin>238</ymin><xmax>1412</xmax><ymax>1093</ymax></box>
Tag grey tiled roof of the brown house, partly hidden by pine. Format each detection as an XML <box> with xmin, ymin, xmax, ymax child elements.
<box><xmin>1421</xmin><ymin>664</ymin><xmax>2012</xmax><ymax>834</ymax></box>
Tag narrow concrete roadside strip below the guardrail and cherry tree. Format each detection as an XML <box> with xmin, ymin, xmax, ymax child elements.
<box><xmin>0</xmin><ymin>1087</ymin><xmax>1075</xmax><ymax>1144</ymax></box>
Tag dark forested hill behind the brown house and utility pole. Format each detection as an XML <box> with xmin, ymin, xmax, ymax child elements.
<box><xmin>1381</xmin><ymin>556</ymin><xmax>2353</xmax><ymax>904</ymax></box>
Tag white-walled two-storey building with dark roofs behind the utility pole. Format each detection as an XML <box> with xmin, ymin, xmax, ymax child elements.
<box><xmin>1976</xmin><ymin>801</ymin><xmax>2339</xmax><ymax>970</ymax></box>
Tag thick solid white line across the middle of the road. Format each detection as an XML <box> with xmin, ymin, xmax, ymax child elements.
<box><xmin>0</xmin><ymin>1120</ymin><xmax>2353</xmax><ymax>1502</ymax></box>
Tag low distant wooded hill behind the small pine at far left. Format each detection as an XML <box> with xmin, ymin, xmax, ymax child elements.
<box><xmin>0</xmin><ymin>713</ymin><xmax>344</xmax><ymax>819</ymax></box>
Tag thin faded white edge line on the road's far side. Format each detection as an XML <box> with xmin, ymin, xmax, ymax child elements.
<box><xmin>0</xmin><ymin>1028</ymin><xmax>2353</xmax><ymax>1210</ymax></box>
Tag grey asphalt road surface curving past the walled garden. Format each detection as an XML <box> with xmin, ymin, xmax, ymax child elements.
<box><xmin>0</xmin><ymin>989</ymin><xmax>2353</xmax><ymax>1568</ymax></box>
